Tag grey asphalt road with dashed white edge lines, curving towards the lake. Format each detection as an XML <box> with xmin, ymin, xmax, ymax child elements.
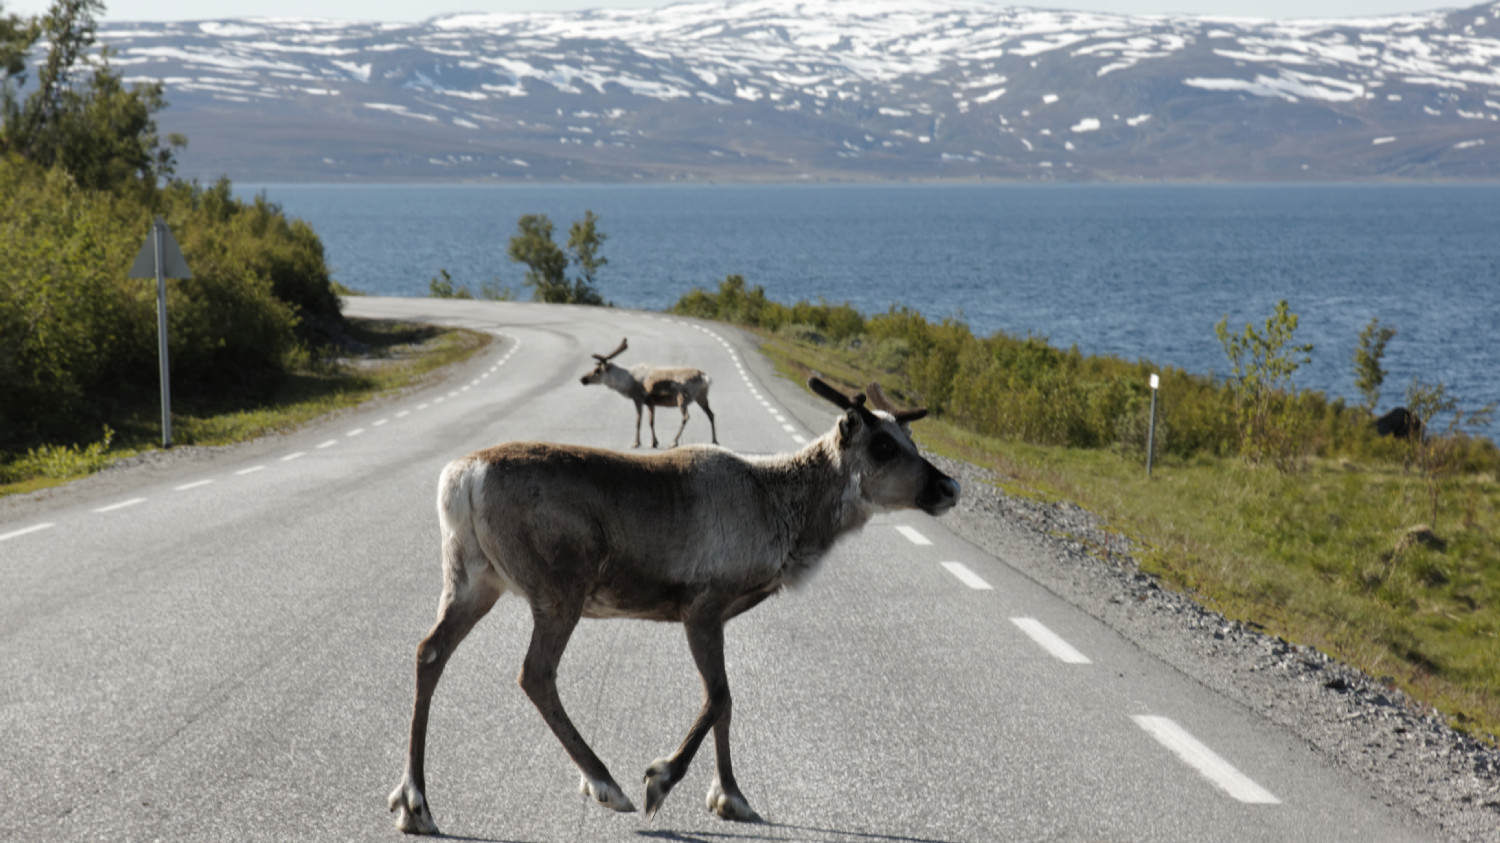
<box><xmin>0</xmin><ymin>299</ymin><xmax>1433</xmax><ymax>843</ymax></box>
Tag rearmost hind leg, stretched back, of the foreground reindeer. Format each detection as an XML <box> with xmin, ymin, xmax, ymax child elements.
<box><xmin>386</xmin><ymin>558</ymin><xmax>504</xmax><ymax>834</ymax></box>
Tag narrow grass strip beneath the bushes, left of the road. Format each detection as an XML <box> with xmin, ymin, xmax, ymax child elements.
<box><xmin>0</xmin><ymin>320</ymin><xmax>492</xmax><ymax>497</ymax></box>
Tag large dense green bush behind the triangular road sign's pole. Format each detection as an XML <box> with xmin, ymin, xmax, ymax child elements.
<box><xmin>0</xmin><ymin>150</ymin><xmax>344</xmax><ymax>455</ymax></box>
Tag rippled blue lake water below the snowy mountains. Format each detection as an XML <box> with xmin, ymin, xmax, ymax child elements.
<box><xmin>240</xmin><ymin>185</ymin><xmax>1500</xmax><ymax>437</ymax></box>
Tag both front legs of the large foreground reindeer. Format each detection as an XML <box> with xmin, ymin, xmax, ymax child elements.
<box><xmin>645</xmin><ymin>614</ymin><xmax>761</xmax><ymax>821</ymax></box>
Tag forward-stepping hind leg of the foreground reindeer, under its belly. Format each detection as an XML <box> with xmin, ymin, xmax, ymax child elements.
<box><xmin>516</xmin><ymin>603</ymin><xmax>636</xmax><ymax>812</ymax></box>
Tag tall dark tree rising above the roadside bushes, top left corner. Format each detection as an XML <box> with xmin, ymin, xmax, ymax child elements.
<box><xmin>0</xmin><ymin>0</ymin><xmax>188</xmax><ymax>192</ymax></box>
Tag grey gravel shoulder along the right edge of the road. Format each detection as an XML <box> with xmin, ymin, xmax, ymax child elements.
<box><xmin>933</xmin><ymin>458</ymin><xmax>1500</xmax><ymax>842</ymax></box>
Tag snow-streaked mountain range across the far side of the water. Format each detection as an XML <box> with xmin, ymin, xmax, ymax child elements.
<box><xmin>99</xmin><ymin>0</ymin><xmax>1500</xmax><ymax>182</ymax></box>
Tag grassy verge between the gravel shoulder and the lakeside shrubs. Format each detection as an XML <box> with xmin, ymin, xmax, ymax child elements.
<box><xmin>761</xmin><ymin>332</ymin><xmax>1500</xmax><ymax>743</ymax></box>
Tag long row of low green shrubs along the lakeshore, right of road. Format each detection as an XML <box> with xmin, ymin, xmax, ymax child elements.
<box><xmin>671</xmin><ymin>275</ymin><xmax>1500</xmax><ymax>471</ymax></box>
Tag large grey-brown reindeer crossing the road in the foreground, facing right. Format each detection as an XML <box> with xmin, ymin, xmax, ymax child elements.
<box><xmin>389</xmin><ymin>378</ymin><xmax>959</xmax><ymax>834</ymax></box>
